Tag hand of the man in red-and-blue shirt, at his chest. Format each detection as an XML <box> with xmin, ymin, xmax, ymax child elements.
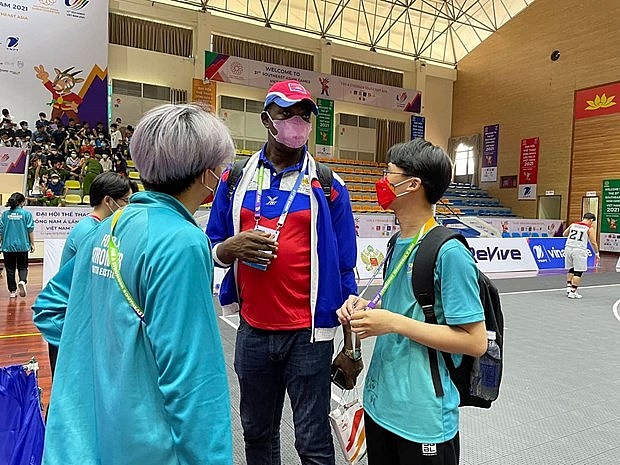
<box><xmin>217</xmin><ymin>230</ymin><xmax>278</xmax><ymax>266</ymax></box>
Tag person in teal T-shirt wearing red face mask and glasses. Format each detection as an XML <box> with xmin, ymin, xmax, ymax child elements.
<box><xmin>338</xmin><ymin>139</ymin><xmax>487</xmax><ymax>465</ymax></box>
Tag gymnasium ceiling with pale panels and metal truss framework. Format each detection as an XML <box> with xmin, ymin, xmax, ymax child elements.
<box><xmin>160</xmin><ymin>0</ymin><xmax>534</xmax><ymax>65</ymax></box>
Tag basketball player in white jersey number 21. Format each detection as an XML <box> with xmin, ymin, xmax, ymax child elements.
<box><xmin>563</xmin><ymin>213</ymin><xmax>601</xmax><ymax>299</ymax></box>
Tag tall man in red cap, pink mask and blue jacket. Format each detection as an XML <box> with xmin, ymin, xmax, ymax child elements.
<box><xmin>207</xmin><ymin>81</ymin><xmax>360</xmax><ymax>465</ymax></box>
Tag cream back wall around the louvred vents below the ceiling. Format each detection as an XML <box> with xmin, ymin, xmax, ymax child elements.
<box><xmin>109</xmin><ymin>0</ymin><xmax>456</xmax><ymax>147</ymax></box>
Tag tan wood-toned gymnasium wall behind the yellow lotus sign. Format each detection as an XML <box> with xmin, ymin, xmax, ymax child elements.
<box><xmin>452</xmin><ymin>0</ymin><xmax>620</xmax><ymax>221</ymax></box>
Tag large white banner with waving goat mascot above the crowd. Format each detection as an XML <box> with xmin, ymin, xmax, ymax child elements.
<box><xmin>0</xmin><ymin>0</ymin><xmax>108</xmax><ymax>126</ymax></box>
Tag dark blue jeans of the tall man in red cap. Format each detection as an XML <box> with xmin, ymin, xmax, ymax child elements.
<box><xmin>235</xmin><ymin>319</ymin><xmax>335</xmax><ymax>465</ymax></box>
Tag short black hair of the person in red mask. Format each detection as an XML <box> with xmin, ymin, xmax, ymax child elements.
<box><xmin>387</xmin><ymin>139</ymin><xmax>452</xmax><ymax>204</ymax></box>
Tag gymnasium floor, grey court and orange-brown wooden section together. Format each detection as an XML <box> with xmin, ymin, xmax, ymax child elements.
<box><xmin>0</xmin><ymin>257</ymin><xmax>620</xmax><ymax>465</ymax></box>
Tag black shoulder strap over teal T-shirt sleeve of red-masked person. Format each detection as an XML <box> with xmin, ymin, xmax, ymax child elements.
<box><xmin>411</xmin><ymin>226</ymin><xmax>467</xmax><ymax>397</ymax></box>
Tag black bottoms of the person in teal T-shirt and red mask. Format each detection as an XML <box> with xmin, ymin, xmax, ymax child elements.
<box><xmin>364</xmin><ymin>414</ymin><xmax>460</xmax><ymax>465</ymax></box>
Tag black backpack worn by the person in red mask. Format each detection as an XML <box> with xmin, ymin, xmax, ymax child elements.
<box><xmin>383</xmin><ymin>226</ymin><xmax>504</xmax><ymax>408</ymax></box>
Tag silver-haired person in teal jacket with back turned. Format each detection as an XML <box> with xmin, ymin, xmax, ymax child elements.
<box><xmin>34</xmin><ymin>105</ymin><xmax>235</xmax><ymax>465</ymax></box>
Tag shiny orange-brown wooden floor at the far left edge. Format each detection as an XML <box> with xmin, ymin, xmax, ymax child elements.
<box><xmin>0</xmin><ymin>263</ymin><xmax>52</xmax><ymax>405</ymax></box>
